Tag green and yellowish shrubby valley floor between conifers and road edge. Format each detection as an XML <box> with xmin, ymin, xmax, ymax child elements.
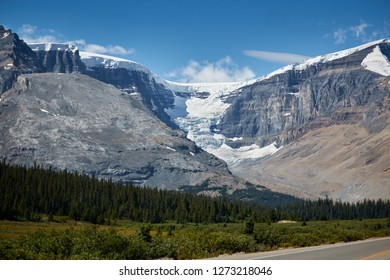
<box><xmin>0</xmin><ymin>217</ymin><xmax>390</xmax><ymax>259</ymax></box>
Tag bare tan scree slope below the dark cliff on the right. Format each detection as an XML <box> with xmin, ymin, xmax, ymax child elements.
<box><xmin>231</xmin><ymin>112</ymin><xmax>390</xmax><ymax>202</ymax></box>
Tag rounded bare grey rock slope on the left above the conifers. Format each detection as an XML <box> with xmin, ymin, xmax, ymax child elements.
<box><xmin>0</xmin><ymin>73</ymin><xmax>245</xmax><ymax>189</ymax></box>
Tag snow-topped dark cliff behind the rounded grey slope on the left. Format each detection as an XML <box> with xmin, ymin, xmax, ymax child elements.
<box><xmin>25</xmin><ymin>43</ymin><xmax>177</xmax><ymax>128</ymax></box>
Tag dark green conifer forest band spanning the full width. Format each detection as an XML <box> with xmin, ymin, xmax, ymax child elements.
<box><xmin>0</xmin><ymin>161</ymin><xmax>390</xmax><ymax>224</ymax></box>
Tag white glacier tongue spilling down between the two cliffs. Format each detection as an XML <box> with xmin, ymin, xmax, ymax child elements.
<box><xmin>165</xmin><ymin>81</ymin><xmax>278</xmax><ymax>167</ymax></box>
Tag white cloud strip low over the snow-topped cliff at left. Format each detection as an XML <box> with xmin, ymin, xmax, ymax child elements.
<box><xmin>18</xmin><ymin>24</ymin><xmax>135</xmax><ymax>55</ymax></box>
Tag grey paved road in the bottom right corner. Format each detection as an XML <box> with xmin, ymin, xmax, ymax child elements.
<box><xmin>216</xmin><ymin>237</ymin><xmax>390</xmax><ymax>260</ymax></box>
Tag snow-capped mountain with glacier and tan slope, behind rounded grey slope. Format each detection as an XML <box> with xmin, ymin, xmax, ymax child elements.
<box><xmin>2</xmin><ymin>24</ymin><xmax>390</xmax><ymax>201</ymax></box>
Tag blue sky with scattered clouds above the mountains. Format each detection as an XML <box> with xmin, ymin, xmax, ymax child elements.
<box><xmin>0</xmin><ymin>0</ymin><xmax>390</xmax><ymax>82</ymax></box>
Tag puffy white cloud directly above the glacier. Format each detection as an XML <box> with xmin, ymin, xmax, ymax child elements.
<box><xmin>168</xmin><ymin>56</ymin><xmax>255</xmax><ymax>83</ymax></box>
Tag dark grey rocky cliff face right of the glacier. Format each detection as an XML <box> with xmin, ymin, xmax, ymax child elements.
<box><xmin>217</xmin><ymin>43</ymin><xmax>390</xmax><ymax>146</ymax></box>
